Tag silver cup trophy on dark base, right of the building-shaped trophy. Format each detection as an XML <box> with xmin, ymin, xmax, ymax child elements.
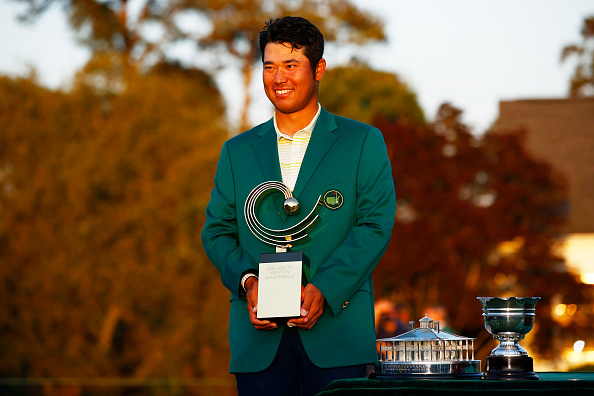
<box><xmin>477</xmin><ymin>297</ymin><xmax>540</xmax><ymax>380</ymax></box>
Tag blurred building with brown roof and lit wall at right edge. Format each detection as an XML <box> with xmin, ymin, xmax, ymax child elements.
<box><xmin>495</xmin><ymin>98</ymin><xmax>594</xmax><ymax>367</ymax></box>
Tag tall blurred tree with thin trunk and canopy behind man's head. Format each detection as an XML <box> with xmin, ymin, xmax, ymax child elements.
<box><xmin>16</xmin><ymin>0</ymin><xmax>385</xmax><ymax>130</ymax></box>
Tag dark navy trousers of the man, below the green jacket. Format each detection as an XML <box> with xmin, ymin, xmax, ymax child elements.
<box><xmin>235</xmin><ymin>326</ymin><xmax>367</xmax><ymax>396</ymax></box>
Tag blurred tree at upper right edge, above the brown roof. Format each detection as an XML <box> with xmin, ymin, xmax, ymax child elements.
<box><xmin>561</xmin><ymin>16</ymin><xmax>594</xmax><ymax>97</ymax></box>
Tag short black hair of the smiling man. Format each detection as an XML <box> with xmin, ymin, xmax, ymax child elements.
<box><xmin>259</xmin><ymin>16</ymin><xmax>324</xmax><ymax>75</ymax></box>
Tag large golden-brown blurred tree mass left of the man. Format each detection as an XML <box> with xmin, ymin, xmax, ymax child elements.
<box><xmin>0</xmin><ymin>64</ymin><xmax>228</xmax><ymax>386</ymax></box>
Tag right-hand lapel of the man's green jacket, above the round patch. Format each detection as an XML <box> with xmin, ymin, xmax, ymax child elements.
<box><xmin>292</xmin><ymin>108</ymin><xmax>338</xmax><ymax>198</ymax></box>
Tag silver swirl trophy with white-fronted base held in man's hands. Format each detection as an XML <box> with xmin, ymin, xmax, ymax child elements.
<box><xmin>244</xmin><ymin>181</ymin><xmax>321</xmax><ymax>322</ymax></box>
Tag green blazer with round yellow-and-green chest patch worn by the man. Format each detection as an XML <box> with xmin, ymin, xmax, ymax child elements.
<box><xmin>202</xmin><ymin>109</ymin><xmax>396</xmax><ymax>373</ymax></box>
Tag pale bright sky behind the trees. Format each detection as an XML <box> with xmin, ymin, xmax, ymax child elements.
<box><xmin>0</xmin><ymin>0</ymin><xmax>594</xmax><ymax>134</ymax></box>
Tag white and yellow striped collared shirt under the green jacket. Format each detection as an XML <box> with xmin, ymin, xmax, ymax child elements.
<box><xmin>274</xmin><ymin>103</ymin><xmax>322</xmax><ymax>191</ymax></box>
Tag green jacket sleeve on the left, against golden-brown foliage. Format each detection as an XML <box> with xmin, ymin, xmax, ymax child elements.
<box><xmin>201</xmin><ymin>143</ymin><xmax>257</xmax><ymax>297</ymax></box>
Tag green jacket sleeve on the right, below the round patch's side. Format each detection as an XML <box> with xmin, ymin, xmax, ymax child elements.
<box><xmin>310</xmin><ymin>127</ymin><xmax>396</xmax><ymax>315</ymax></box>
